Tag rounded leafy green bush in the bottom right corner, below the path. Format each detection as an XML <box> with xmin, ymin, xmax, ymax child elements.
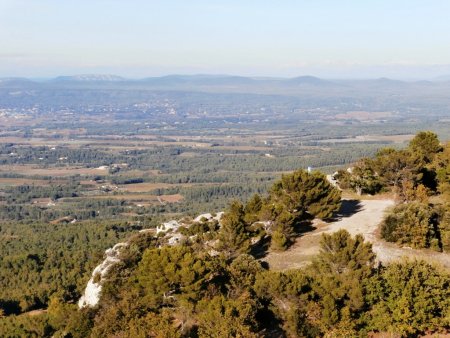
<box><xmin>368</xmin><ymin>261</ymin><xmax>450</xmax><ymax>336</ymax></box>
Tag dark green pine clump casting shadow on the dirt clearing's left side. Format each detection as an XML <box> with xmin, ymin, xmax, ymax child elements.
<box><xmin>214</xmin><ymin>170</ymin><xmax>341</xmax><ymax>251</ymax></box>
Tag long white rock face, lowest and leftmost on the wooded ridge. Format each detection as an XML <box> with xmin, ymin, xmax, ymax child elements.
<box><xmin>78</xmin><ymin>243</ymin><xmax>128</xmax><ymax>308</ymax></box>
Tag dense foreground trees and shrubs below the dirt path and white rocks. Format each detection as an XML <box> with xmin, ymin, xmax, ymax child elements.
<box><xmin>4</xmin><ymin>231</ymin><xmax>450</xmax><ymax>337</ymax></box>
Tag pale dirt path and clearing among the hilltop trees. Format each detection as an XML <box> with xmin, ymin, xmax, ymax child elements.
<box><xmin>263</xmin><ymin>199</ymin><xmax>450</xmax><ymax>270</ymax></box>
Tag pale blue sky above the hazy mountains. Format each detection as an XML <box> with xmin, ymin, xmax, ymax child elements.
<box><xmin>0</xmin><ymin>0</ymin><xmax>450</xmax><ymax>79</ymax></box>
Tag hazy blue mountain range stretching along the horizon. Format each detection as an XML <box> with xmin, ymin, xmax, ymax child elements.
<box><xmin>0</xmin><ymin>74</ymin><xmax>450</xmax><ymax>96</ymax></box>
